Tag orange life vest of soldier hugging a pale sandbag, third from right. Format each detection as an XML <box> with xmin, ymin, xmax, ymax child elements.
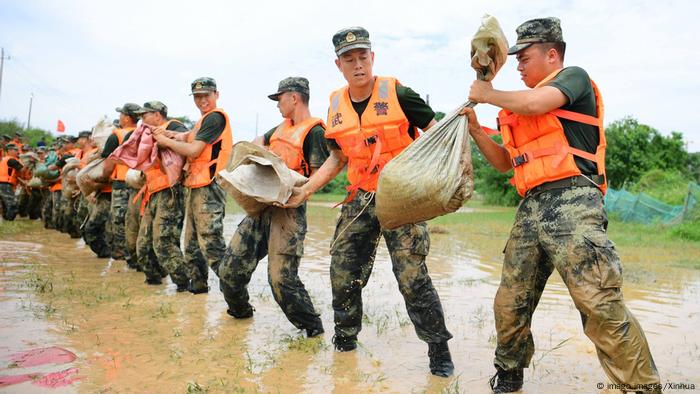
<box><xmin>270</xmin><ymin>118</ymin><xmax>325</xmax><ymax>176</ymax></box>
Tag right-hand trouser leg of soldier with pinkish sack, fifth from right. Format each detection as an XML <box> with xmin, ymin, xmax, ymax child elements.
<box><xmin>149</xmin><ymin>183</ymin><xmax>189</xmax><ymax>286</ymax></box>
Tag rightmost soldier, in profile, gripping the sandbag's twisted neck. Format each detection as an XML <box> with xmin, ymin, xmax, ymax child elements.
<box><xmin>465</xmin><ymin>18</ymin><xmax>661</xmax><ymax>393</ymax></box>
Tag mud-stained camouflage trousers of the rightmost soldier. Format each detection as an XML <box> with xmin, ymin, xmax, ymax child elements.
<box><xmin>494</xmin><ymin>186</ymin><xmax>659</xmax><ymax>385</ymax></box>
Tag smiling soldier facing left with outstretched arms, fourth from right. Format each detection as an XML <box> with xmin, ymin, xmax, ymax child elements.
<box><xmin>154</xmin><ymin>77</ymin><xmax>233</xmax><ymax>294</ymax></box>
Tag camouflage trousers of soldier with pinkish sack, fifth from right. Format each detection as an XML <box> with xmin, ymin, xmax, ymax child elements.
<box><xmin>136</xmin><ymin>183</ymin><xmax>189</xmax><ymax>287</ymax></box>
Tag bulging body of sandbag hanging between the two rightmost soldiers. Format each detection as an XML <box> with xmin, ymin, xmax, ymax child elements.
<box><xmin>375</xmin><ymin>106</ymin><xmax>474</xmax><ymax>229</ymax></box>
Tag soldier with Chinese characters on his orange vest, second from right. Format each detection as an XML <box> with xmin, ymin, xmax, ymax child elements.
<box><xmin>287</xmin><ymin>27</ymin><xmax>454</xmax><ymax>377</ymax></box>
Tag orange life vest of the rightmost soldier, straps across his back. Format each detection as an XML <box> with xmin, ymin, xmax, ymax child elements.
<box><xmin>498</xmin><ymin>69</ymin><xmax>607</xmax><ymax>197</ymax></box>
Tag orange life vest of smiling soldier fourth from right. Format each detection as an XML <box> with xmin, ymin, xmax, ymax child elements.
<box><xmin>183</xmin><ymin>108</ymin><xmax>233</xmax><ymax>189</ymax></box>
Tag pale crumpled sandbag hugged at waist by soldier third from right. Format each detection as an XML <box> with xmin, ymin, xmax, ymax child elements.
<box><xmin>216</xmin><ymin>141</ymin><xmax>308</xmax><ymax>216</ymax></box>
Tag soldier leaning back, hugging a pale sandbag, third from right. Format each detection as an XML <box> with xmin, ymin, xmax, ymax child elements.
<box><xmin>219</xmin><ymin>77</ymin><xmax>328</xmax><ymax>337</ymax></box>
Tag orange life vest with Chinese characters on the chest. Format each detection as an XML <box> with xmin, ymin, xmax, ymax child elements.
<box><xmin>326</xmin><ymin>77</ymin><xmax>413</xmax><ymax>195</ymax></box>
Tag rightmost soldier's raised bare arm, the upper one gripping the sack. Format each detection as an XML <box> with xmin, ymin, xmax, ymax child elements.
<box><xmin>469</xmin><ymin>80</ymin><xmax>569</xmax><ymax>115</ymax></box>
